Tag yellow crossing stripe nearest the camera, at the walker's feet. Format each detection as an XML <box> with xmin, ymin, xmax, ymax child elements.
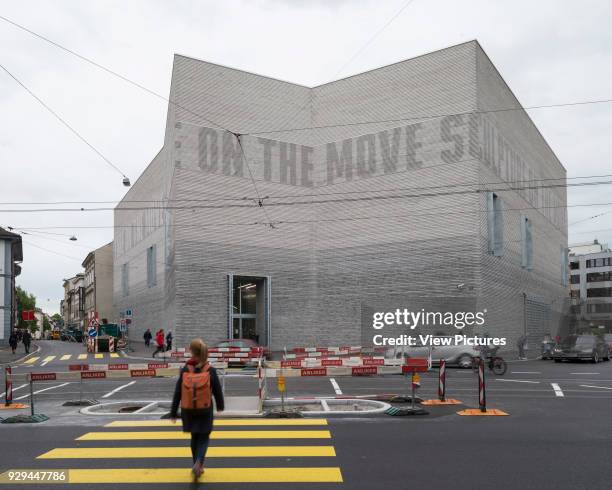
<box><xmin>0</xmin><ymin>467</ymin><xmax>342</xmax><ymax>484</ymax></box>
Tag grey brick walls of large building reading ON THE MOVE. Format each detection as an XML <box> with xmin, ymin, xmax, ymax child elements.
<box><xmin>114</xmin><ymin>41</ymin><xmax>567</xmax><ymax>349</ymax></box>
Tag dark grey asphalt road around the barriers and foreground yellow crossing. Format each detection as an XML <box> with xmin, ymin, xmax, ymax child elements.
<box><xmin>0</xmin><ymin>342</ymin><xmax>612</xmax><ymax>490</ymax></box>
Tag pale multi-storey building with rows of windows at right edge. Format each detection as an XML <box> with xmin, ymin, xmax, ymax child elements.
<box><xmin>569</xmin><ymin>240</ymin><xmax>612</xmax><ymax>333</ymax></box>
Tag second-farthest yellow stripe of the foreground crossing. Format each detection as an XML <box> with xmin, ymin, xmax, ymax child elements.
<box><xmin>76</xmin><ymin>430</ymin><xmax>331</xmax><ymax>441</ymax></box>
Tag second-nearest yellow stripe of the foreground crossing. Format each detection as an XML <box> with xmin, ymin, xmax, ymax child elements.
<box><xmin>37</xmin><ymin>446</ymin><xmax>336</xmax><ymax>459</ymax></box>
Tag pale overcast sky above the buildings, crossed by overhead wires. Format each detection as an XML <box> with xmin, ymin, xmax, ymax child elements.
<box><xmin>0</xmin><ymin>0</ymin><xmax>612</xmax><ymax>313</ymax></box>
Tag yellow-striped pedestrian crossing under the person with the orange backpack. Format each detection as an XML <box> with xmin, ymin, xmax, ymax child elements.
<box><xmin>0</xmin><ymin>418</ymin><xmax>343</xmax><ymax>488</ymax></box>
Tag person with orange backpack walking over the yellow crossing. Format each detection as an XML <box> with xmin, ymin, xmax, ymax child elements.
<box><xmin>170</xmin><ymin>339</ymin><xmax>225</xmax><ymax>480</ymax></box>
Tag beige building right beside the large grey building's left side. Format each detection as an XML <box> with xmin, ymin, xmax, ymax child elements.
<box><xmin>83</xmin><ymin>242</ymin><xmax>115</xmax><ymax>322</ymax></box>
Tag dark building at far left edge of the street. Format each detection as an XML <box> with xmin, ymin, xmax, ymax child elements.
<box><xmin>0</xmin><ymin>228</ymin><xmax>23</xmax><ymax>344</ymax></box>
